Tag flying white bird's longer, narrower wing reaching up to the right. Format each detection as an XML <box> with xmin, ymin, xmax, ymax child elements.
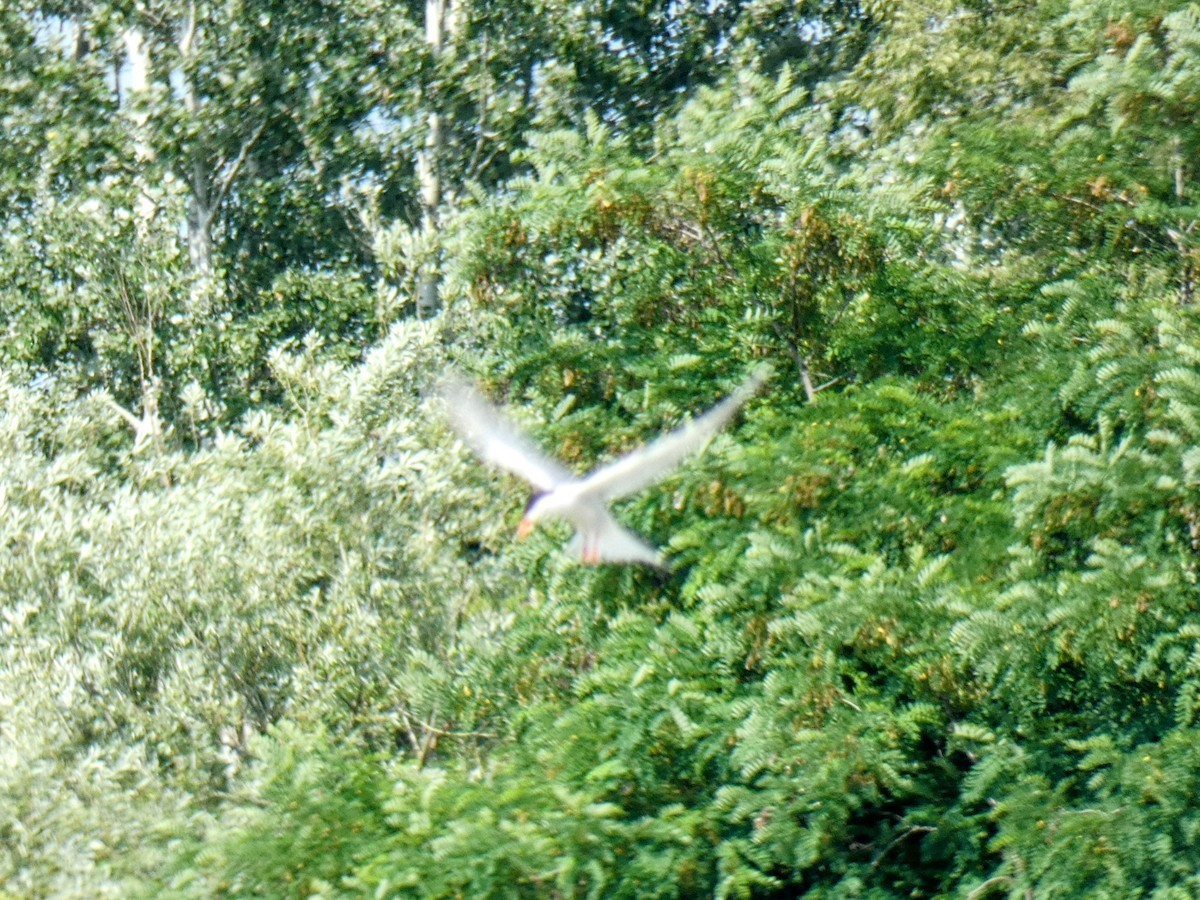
<box><xmin>583</xmin><ymin>366</ymin><xmax>770</xmax><ymax>500</ymax></box>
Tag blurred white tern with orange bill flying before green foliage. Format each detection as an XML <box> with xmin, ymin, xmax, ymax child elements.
<box><xmin>440</xmin><ymin>365</ymin><xmax>770</xmax><ymax>568</ymax></box>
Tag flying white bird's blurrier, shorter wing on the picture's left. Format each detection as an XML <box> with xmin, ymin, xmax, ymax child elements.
<box><xmin>438</xmin><ymin>374</ymin><xmax>575</xmax><ymax>491</ymax></box>
